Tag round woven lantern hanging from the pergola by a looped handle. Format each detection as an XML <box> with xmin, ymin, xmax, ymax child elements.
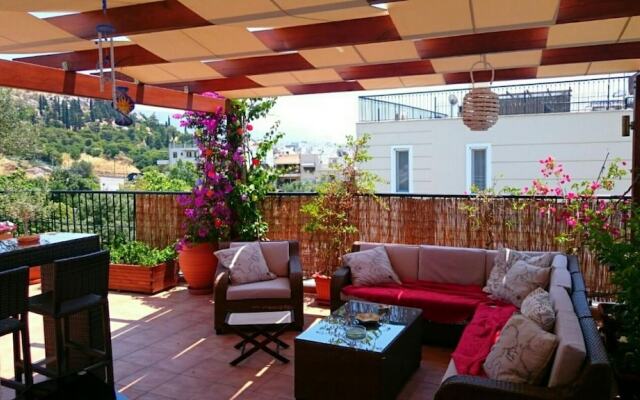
<box><xmin>462</xmin><ymin>61</ymin><xmax>500</xmax><ymax>131</ymax></box>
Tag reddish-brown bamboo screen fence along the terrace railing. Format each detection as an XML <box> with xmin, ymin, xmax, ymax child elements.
<box><xmin>136</xmin><ymin>194</ymin><xmax>615</xmax><ymax>297</ymax></box>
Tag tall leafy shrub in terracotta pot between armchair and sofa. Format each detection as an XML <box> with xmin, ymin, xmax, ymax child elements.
<box><xmin>301</xmin><ymin>135</ymin><xmax>380</xmax><ymax>303</ymax></box>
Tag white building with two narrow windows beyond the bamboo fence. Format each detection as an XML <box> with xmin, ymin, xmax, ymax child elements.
<box><xmin>357</xmin><ymin>77</ymin><xmax>631</xmax><ymax>194</ymax></box>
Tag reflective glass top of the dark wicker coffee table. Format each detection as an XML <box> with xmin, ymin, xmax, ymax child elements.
<box><xmin>296</xmin><ymin>300</ymin><xmax>422</xmax><ymax>353</ymax></box>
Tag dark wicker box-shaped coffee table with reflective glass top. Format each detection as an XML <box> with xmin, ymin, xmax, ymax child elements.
<box><xmin>295</xmin><ymin>301</ymin><xmax>422</xmax><ymax>400</ymax></box>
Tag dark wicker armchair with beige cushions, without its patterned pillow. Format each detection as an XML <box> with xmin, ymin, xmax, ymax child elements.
<box><xmin>213</xmin><ymin>241</ymin><xmax>304</xmax><ymax>334</ymax></box>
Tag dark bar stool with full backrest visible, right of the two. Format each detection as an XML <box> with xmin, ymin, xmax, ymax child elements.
<box><xmin>29</xmin><ymin>251</ymin><xmax>113</xmax><ymax>385</ymax></box>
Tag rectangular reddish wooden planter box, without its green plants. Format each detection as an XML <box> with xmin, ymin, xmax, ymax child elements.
<box><xmin>109</xmin><ymin>261</ymin><xmax>178</xmax><ymax>294</ymax></box>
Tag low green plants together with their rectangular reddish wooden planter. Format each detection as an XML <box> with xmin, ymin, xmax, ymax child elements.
<box><xmin>109</xmin><ymin>241</ymin><xmax>178</xmax><ymax>294</ymax></box>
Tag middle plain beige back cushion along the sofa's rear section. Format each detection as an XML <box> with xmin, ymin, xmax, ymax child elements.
<box><xmin>418</xmin><ymin>246</ymin><xmax>485</xmax><ymax>286</ymax></box>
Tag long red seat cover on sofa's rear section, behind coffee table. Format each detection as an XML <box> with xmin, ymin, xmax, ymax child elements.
<box><xmin>342</xmin><ymin>281</ymin><xmax>489</xmax><ymax>324</ymax></box>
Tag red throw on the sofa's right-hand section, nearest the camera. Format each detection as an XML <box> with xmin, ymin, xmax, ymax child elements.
<box><xmin>451</xmin><ymin>303</ymin><xmax>517</xmax><ymax>376</ymax></box>
